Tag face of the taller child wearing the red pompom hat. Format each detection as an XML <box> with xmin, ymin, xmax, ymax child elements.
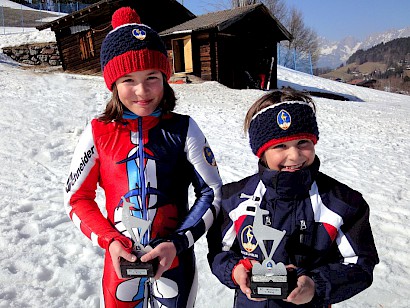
<box><xmin>115</xmin><ymin>70</ymin><xmax>164</xmax><ymax>117</ymax></box>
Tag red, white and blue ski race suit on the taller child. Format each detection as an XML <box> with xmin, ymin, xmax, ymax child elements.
<box><xmin>65</xmin><ymin>112</ymin><xmax>222</xmax><ymax>308</ymax></box>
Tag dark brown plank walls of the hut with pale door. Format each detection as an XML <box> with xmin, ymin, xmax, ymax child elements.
<box><xmin>164</xmin><ymin>31</ymin><xmax>277</xmax><ymax>89</ymax></box>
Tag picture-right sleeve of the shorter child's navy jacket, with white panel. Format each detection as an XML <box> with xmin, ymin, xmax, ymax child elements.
<box><xmin>310</xmin><ymin>196</ymin><xmax>379</xmax><ymax>305</ymax></box>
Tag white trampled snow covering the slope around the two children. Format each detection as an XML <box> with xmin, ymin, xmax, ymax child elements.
<box><xmin>0</xmin><ymin>18</ymin><xmax>410</xmax><ymax>308</ymax></box>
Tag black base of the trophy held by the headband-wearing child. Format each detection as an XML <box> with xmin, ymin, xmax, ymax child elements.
<box><xmin>251</xmin><ymin>270</ymin><xmax>297</xmax><ymax>299</ymax></box>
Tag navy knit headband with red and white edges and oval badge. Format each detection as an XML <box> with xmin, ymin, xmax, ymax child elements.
<box><xmin>249</xmin><ymin>101</ymin><xmax>319</xmax><ymax>158</ymax></box>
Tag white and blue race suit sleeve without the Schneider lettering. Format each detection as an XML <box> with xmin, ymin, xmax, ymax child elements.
<box><xmin>150</xmin><ymin>118</ymin><xmax>222</xmax><ymax>254</ymax></box>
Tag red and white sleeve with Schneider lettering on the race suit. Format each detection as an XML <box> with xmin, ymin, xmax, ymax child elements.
<box><xmin>64</xmin><ymin>124</ymin><xmax>132</xmax><ymax>249</ymax></box>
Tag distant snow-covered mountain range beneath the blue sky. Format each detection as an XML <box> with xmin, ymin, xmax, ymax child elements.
<box><xmin>318</xmin><ymin>27</ymin><xmax>410</xmax><ymax>68</ymax></box>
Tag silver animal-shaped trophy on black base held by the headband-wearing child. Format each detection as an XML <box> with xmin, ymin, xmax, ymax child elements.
<box><xmin>251</xmin><ymin>206</ymin><xmax>297</xmax><ymax>299</ymax></box>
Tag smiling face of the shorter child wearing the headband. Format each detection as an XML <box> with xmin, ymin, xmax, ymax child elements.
<box><xmin>264</xmin><ymin>139</ymin><xmax>315</xmax><ymax>172</ymax></box>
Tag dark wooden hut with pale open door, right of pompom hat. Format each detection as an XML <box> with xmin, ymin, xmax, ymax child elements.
<box><xmin>160</xmin><ymin>4</ymin><xmax>292</xmax><ymax>89</ymax></box>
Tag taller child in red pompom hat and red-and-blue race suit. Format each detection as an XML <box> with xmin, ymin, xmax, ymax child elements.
<box><xmin>65</xmin><ymin>8</ymin><xmax>222</xmax><ymax>308</ymax></box>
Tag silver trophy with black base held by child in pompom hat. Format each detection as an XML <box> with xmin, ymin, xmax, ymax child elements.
<box><xmin>120</xmin><ymin>197</ymin><xmax>158</xmax><ymax>278</ymax></box>
